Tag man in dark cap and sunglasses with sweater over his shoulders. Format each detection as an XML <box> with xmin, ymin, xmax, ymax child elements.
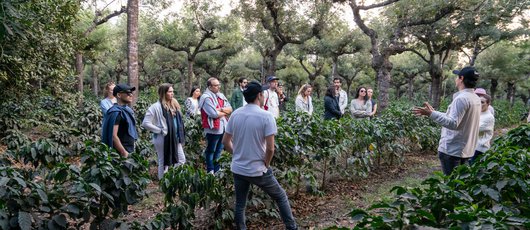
<box><xmin>101</xmin><ymin>84</ymin><xmax>138</xmax><ymax>157</ymax></box>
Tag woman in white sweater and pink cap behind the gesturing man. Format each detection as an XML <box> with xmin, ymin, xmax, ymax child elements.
<box><xmin>469</xmin><ymin>94</ymin><xmax>495</xmax><ymax>164</ymax></box>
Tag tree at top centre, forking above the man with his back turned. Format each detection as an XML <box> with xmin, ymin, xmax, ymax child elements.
<box><xmin>239</xmin><ymin>0</ymin><xmax>331</xmax><ymax>80</ymax></box>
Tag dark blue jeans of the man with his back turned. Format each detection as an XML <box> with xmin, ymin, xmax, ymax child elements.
<box><xmin>233</xmin><ymin>169</ymin><xmax>297</xmax><ymax>230</ymax></box>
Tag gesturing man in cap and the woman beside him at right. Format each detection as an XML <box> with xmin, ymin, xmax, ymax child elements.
<box><xmin>412</xmin><ymin>67</ymin><xmax>495</xmax><ymax>175</ymax></box>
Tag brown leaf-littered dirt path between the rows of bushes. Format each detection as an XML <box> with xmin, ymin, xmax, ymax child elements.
<box><xmin>124</xmin><ymin>154</ymin><xmax>440</xmax><ymax>229</ymax></box>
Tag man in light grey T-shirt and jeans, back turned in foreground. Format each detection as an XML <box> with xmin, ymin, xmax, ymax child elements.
<box><xmin>223</xmin><ymin>81</ymin><xmax>297</xmax><ymax>229</ymax></box>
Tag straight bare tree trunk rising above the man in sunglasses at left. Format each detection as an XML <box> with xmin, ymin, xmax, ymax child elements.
<box><xmin>127</xmin><ymin>0</ymin><xmax>140</xmax><ymax>105</ymax></box>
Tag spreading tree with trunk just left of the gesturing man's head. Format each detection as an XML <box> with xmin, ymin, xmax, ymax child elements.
<box><xmin>402</xmin><ymin>0</ymin><xmax>524</xmax><ymax>107</ymax></box>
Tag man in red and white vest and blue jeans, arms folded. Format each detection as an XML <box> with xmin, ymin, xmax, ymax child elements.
<box><xmin>199</xmin><ymin>77</ymin><xmax>232</xmax><ymax>174</ymax></box>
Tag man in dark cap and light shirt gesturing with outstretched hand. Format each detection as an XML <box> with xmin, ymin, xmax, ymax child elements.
<box><xmin>412</xmin><ymin>67</ymin><xmax>481</xmax><ymax>175</ymax></box>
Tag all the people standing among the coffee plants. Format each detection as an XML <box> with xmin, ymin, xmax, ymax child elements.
<box><xmin>96</xmin><ymin>67</ymin><xmax>520</xmax><ymax>229</ymax></box>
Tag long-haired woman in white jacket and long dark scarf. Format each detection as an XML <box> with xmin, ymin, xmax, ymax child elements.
<box><xmin>142</xmin><ymin>83</ymin><xmax>186</xmax><ymax>179</ymax></box>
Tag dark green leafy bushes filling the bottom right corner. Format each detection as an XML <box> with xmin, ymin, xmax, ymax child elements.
<box><xmin>338</xmin><ymin>124</ymin><xmax>530</xmax><ymax>229</ymax></box>
